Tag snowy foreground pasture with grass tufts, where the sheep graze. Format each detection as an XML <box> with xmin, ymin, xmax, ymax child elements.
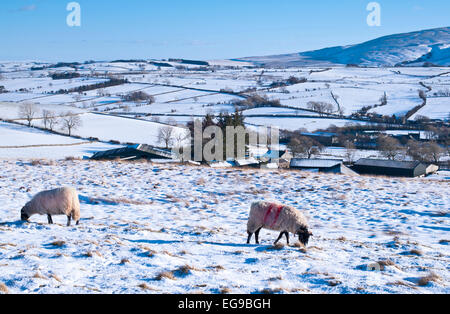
<box><xmin>0</xmin><ymin>160</ymin><xmax>450</xmax><ymax>293</ymax></box>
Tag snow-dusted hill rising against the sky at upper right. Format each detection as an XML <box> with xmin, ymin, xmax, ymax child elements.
<box><xmin>241</xmin><ymin>27</ymin><xmax>450</xmax><ymax>67</ymax></box>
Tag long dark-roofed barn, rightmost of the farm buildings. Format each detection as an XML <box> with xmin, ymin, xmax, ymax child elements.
<box><xmin>352</xmin><ymin>159</ymin><xmax>428</xmax><ymax>178</ymax></box>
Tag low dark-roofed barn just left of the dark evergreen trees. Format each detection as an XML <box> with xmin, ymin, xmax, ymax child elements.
<box><xmin>91</xmin><ymin>144</ymin><xmax>173</xmax><ymax>160</ymax></box>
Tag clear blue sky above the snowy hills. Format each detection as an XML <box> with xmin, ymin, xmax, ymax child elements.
<box><xmin>0</xmin><ymin>0</ymin><xmax>450</xmax><ymax>61</ymax></box>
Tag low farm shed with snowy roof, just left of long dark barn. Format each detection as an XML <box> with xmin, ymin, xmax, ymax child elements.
<box><xmin>290</xmin><ymin>158</ymin><xmax>356</xmax><ymax>175</ymax></box>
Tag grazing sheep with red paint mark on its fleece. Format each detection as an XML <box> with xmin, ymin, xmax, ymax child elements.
<box><xmin>247</xmin><ymin>202</ymin><xmax>312</xmax><ymax>245</ymax></box>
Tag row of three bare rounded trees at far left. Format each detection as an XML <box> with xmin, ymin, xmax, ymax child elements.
<box><xmin>19</xmin><ymin>103</ymin><xmax>82</xmax><ymax>136</ymax></box>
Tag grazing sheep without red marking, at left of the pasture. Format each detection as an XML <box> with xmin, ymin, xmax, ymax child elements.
<box><xmin>21</xmin><ymin>188</ymin><xmax>80</xmax><ymax>226</ymax></box>
